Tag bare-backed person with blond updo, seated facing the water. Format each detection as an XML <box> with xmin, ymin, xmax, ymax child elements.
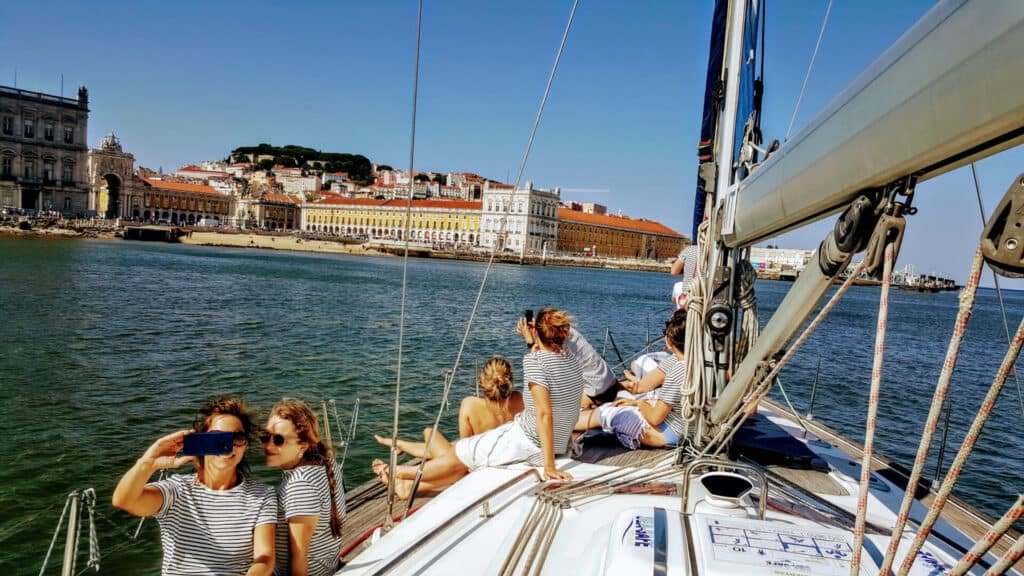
<box><xmin>374</xmin><ymin>356</ymin><xmax>523</xmax><ymax>458</ymax></box>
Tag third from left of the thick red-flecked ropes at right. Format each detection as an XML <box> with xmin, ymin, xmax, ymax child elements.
<box><xmin>899</xmin><ymin>319</ymin><xmax>1024</xmax><ymax>576</ymax></box>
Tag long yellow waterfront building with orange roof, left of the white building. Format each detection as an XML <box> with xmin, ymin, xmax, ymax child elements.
<box><xmin>302</xmin><ymin>196</ymin><xmax>482</xmax><ymax>246</ymax></box>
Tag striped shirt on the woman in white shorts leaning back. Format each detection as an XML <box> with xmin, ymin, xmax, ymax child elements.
<box><xmin>515</xmin><ymin>348</ymin><xmax>585</xmax><ymax>454</ymax></box>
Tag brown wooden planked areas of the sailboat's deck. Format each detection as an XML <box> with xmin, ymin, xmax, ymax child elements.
<box><xmin>342</xmin><ymin>401</ymin><xmax>1024</xmax><ymax>574</ymax></box>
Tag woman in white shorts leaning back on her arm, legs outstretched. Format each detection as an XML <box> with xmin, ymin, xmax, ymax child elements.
<box><xmin>373</xmin><ymin>308</ymin><xmax>584</xmax><ymax>498</ymax></box>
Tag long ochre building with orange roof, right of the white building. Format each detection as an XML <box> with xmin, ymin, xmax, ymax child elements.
<box><xmin>558</xmin><ymin>207</ymin><xmax>690</xmax><ymax>259</ymax></box>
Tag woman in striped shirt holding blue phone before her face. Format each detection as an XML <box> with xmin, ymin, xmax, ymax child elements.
<box><xmin>113</xmin><ymin>398</ymin><xmax>278</xmax><ymax>576</ymax></box>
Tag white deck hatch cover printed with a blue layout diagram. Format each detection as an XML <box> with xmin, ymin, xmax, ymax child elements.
<box><xmin>692</xmin><ymin>515</ymin><xmax>856</xmax><ymax>576</ymax></box>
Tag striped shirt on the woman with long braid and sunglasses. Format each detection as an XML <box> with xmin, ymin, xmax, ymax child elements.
<box><xmin>274</xmin><ymin>464</ymin><xmax>345</xmax><ymax>576</ymax></box>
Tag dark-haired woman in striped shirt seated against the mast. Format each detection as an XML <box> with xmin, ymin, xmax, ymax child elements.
<box><xmin>575</xmin><ymin>310</ymin><xmax>687</xmax><ymax>449</ymax></box>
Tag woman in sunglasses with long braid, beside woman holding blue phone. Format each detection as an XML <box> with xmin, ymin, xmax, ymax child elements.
<box><xmin>260</xmin><ymin>398</ymin><xmax>345</xmax><ymax>576</ymax></box>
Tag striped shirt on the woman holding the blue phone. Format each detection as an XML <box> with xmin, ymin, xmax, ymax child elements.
<box><xmin>148</xmin><ymin>474</ymin><xmax>278</xmax><ymax>576</ymax></box>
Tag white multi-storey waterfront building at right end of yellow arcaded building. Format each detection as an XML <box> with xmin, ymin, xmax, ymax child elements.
<box><xmin>480</xmin><ymin>180</ymin><xmax>561</xmax><ymax>254</ymax></box>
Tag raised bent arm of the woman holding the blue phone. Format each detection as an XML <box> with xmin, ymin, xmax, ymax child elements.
<box><xmin>111</xmin><ymin>430</ymin><xmax>195</xmax><ymax>517</ymax></box>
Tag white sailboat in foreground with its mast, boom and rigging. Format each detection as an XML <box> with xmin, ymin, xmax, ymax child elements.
<box><xmin>331</xmin><ymin>0</ymin><xmax>1024</xmax><ymax>576</ymax></box>
